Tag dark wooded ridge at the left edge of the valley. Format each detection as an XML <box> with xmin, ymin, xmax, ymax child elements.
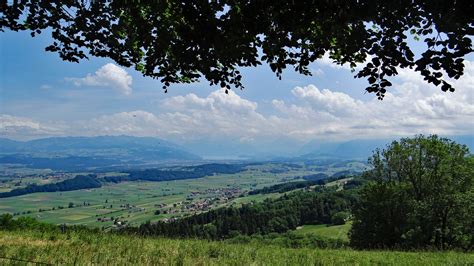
<box><xmin>0</xmin><ymin>175</ymin><xmax>102</xmax><ymax>198</ymax></box>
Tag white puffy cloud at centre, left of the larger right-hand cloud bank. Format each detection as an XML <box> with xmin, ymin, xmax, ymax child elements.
<box><xmin>154</xmin><ymin>89</ymin><xmax>271</xmax><ymax>139</ymax></box>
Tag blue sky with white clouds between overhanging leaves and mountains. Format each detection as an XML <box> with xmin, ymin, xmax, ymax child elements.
<box><xmin>0</xmin><ymin>29</ymin><xmax>474</xmax><ymax>150</ymax></box>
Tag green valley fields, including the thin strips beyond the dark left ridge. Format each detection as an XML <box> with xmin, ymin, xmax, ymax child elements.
<box><xmin>0</xmin><ymin>162</ymin><xmax>362</xmax><ymax>228</ymax></box>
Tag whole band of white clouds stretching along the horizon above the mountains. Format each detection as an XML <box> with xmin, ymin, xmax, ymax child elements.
<box><xmin>2</xmin><ymin>61</ymin><xmax>474</xmax><ymax>140</ymax></box>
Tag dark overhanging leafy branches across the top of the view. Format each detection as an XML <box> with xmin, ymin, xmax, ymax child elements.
<box><xmin>0</xmin><ymin>0</ymin><xmax>474</xmax><ymax>99</ymax></box>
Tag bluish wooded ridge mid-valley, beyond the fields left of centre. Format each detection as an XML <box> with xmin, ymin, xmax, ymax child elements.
<box><xmin>104</xmin><ymin>163</ymin><xmax>244</xmax><ymax>183</ymax></box>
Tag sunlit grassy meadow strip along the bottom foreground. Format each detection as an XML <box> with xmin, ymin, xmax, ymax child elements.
<box><xmin>0</xmin><ymin>231</ymin><xmax>474</xmax><ymax>265</ymax></box>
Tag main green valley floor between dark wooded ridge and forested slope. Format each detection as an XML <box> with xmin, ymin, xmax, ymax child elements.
<box><xmin>0</xmin><ymin>166</ymin><xmax>308</xmax><ymax>227</ymax></box>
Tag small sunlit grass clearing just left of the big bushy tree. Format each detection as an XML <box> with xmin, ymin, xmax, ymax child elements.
<box><xmin>294</xmin><ymin>223</ymin><xmax>351</xmax><ymax>241</ymax></box>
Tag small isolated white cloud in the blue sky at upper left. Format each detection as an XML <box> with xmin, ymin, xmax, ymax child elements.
<box><xmin>67</xmin><ymin>63</ymin><xmax>133</xmax><ymax>95</ymax></box>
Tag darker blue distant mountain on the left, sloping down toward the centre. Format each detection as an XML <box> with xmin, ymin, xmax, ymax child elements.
<box><xmin>0</xmin><ymin>136</ymin><xmax>201</xmax><ymax>168</ymax></box>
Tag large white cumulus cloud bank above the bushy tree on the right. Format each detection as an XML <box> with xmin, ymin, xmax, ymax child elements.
<box><xmin>273</xmin><ymin>61</ymin><xmax>474</xmax><ymax>139</ymax></box>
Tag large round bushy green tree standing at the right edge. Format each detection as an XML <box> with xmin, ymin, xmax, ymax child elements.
<box><xmin>350</xmin><ymin>135</ymin><xmax>474</xmax><ymax>249</ymax></box>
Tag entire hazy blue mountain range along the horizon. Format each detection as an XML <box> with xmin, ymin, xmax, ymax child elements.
<box><xmin>0</xmin><ymin>135</ymin><xmax>474</xmax><ymax>169</ymax></box>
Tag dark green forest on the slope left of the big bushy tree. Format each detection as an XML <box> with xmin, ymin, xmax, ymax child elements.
<box><xmin>130</xmin><ymin>191</ymin><xmax>356</xmax><ymax>239</ymax></box>
